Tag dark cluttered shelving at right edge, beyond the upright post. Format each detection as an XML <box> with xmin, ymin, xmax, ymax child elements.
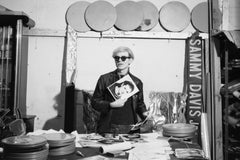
<box><xmin>214</xmin><ymin>31</ymin><xmax>240</xmax><ymax>160</ymax></box>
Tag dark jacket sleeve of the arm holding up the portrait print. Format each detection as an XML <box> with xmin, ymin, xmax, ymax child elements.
<box><xmin>92</xmin><ymin>77</ymin><xmax>110</xmax><ymax>114</ymax></box>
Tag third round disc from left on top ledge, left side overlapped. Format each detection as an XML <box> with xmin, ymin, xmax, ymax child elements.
<box><xmin>115</xmin><ymin>1</ymin><xmax>143</xmax><ymax>31</ymax></box>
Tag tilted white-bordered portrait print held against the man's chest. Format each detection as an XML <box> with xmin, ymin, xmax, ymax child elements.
<box><xmin>108</xmin><ymin>75</ymin><xmax>139</xmax><ymax>100</ymax></box>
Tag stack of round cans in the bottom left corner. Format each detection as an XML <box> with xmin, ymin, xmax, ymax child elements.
<box><xmin>2</xmin><ymin>135</ymin><xmax>48</xmax><ymax>160</ymax></box>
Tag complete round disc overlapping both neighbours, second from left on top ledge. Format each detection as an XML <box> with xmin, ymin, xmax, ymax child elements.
<box><xmin>85</xmin><ymin>0</ymin><xmax>117</xmax><ymax>31</ymax></box>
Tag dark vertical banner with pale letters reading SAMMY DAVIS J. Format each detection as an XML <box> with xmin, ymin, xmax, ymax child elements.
<box><xmin>186</xmin><ymin>37</ymin><xmax>203</xmax><ymax>136</ymax></box>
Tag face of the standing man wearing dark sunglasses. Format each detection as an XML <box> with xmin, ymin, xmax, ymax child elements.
<box><xmin>115</xmin><ymin>52</ymin><xmax>132</xmax><ymax>70</ymax></box>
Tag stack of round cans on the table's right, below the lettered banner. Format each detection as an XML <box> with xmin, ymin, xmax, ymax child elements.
<box><xmin>162</xmin><ymin>123</ymin><xmax>197</xmax><ymax>138</ymax></box>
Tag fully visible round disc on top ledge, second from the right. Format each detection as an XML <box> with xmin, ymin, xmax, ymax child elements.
<box><xmin>159</xmin><ymin>1</ymin><xmax>190</xmax><ymax>32</ymax></box>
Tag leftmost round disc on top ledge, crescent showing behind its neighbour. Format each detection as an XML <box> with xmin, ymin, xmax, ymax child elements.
<box><xmin>66</xmin><ymin>1</ymin><xmax>91</xmax><ymax>32</ymax></box>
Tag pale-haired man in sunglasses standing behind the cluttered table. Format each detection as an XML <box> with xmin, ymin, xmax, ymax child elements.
<box><xmin>92</xmin><ymin>46</ymin><xmax>147</xmax><ymax>134</ymax></box>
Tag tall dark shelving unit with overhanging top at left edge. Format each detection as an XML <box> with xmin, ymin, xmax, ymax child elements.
<box><xmin>0</xmin><ymin>9</ymin><xmax>35</xmax><ymax>115</ymax></box>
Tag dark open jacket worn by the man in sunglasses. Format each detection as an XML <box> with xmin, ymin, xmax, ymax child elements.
<box><xmin>92</xmin><ymin>70</ymin><xmax>146</xmax><ymax>133</ymax></box>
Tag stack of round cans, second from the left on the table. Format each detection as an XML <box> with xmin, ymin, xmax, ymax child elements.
<box><xmin>43</xmin><ymin>133</ymin><xmax>76</xmax><ymax>156</ymax></box>
